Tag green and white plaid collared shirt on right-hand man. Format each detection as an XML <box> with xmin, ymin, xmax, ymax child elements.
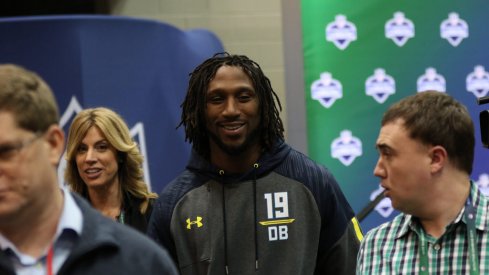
<box><xmin>357</xmin><ymin>183</ymin><xmax>489</xmax><ymax>274</ymax></box>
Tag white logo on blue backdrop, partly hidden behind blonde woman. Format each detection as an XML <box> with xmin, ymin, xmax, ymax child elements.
<box><xmin>58</xmin><ymin>96</ymin><xmax>151</xmax><ymax>190</ymax></box>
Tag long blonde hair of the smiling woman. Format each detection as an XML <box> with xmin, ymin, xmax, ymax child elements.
<box><xmin>65</xmin><ymin>107</ymin><xmax>157</xmax><ymax>214</ymax></box>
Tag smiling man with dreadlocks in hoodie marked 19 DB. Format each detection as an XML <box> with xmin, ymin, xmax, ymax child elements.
<box><xmin>148</xmin><ymin>53</ymin><xmax>362</xmax><ymax>275</ymax></box>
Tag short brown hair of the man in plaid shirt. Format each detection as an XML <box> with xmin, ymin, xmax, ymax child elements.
<box><xmin>382</xmin><ymin>91</ymin><xmax>475</xmax><ymax>174</ymax></box>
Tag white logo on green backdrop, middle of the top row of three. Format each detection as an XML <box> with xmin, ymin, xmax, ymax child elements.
<box><xmin>385</xmin><ymin>11</ymin><xmax>414</xmax><ymax>47</ymax></box>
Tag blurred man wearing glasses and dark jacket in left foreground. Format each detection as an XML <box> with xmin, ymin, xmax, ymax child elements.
<box><xmin>0</xmin><ymin>65</ymin><xmax>176</xmax><ymax>275</ymax></box>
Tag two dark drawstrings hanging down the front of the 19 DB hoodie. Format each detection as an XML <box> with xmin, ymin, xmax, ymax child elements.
<box><xmin>219</xmin><ymin>163</ymin><xmax>260</xmax><ymax>275</ymax></box>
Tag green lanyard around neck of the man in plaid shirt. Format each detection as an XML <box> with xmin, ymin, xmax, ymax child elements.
<box><xmin>419</xmin><ymin>195</ymin><xmax>479</xmax><ymax>275</ymax></box>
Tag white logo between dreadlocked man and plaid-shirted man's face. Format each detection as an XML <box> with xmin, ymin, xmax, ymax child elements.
<box><xmin>331</xmin><ymin>130</ymin><xmax>362</xmax><ymax>166</ymax></box>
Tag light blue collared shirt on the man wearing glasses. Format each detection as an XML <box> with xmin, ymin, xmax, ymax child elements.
<box><xmin>0</xmin><ymin>189</ymin><xmax>83</xmax><ymax>275</ymax></box>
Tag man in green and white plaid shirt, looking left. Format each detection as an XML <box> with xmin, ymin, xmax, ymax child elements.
<box><xmin>357</xmin><ymin>91</ymin><xmax>489</xmax><ymax>274</ymax></box>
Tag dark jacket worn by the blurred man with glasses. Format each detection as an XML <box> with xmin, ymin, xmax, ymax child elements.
<box><xmin>0</xmin><ymin>193</ymin><xmax>177</xmax><ymax>275</ymax></box>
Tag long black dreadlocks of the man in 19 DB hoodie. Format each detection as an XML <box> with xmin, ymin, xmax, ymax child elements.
<box><xmin>177</xmin><ymin>52</ymin><xmax>284</xmax><ymax>157</ymax></box>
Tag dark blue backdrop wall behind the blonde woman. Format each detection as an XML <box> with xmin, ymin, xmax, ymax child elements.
<box><xmin>0</xmin><ymin>16</ymin><xmax>223</xmax><ymax>193</ymax></box>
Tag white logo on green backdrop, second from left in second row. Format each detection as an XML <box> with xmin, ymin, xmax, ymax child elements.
<box><xmin>365</xmin><ymin>68</ymin><xmax>396</xmax><ymax>104</ymax></box>
